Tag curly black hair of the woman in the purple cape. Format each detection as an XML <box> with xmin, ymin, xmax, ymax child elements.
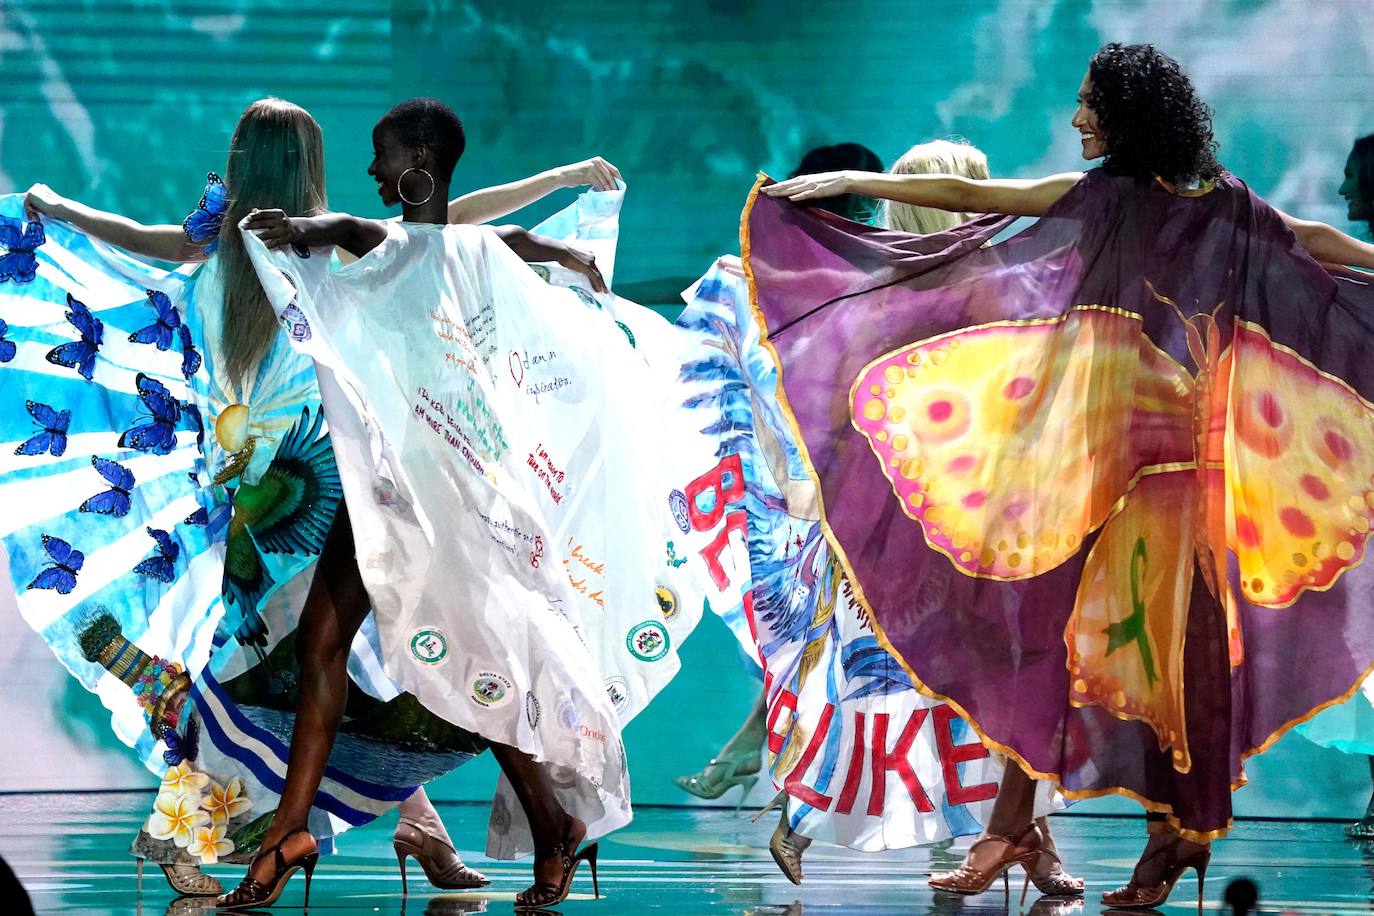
<box><xmin>1087</xmin><ymin>43</ymin><xmax>1223</xmax><ymax>184</ymax></box>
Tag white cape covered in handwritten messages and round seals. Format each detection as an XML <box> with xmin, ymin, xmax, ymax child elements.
<box><xmin>245</xmin><ymin>192</ymin><xmax>728</xmax><ymax>856</ymax></box>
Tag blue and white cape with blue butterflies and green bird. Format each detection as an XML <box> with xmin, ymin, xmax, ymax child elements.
<box><xmin>0</xmin><ymin>183</ymin><xmax>485</xmax><ymax>864</ymax></box>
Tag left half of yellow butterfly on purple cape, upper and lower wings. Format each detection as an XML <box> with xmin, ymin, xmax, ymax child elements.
<box><xmin>851</xmin><ymin>308</ymin><xmax>1197</xmax><ymax>768</ymax></box>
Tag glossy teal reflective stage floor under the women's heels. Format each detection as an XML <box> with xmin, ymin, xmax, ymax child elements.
<box><xmin>0</xmin><ymin>792</ymin><xmax>1374</xmax><ymax>916</ymax></box>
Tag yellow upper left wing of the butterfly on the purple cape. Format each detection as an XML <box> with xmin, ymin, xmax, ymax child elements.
<box><xmin>851</xmin><ymin>308</ymin><xmax>1193</xmax><ymax>580</ymax></box>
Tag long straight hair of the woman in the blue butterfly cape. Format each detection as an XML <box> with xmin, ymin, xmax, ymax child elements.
<box><xmin>217</xmin><ymin>99</ymin><xmax>328</xmax><ymax>386</ymax></box>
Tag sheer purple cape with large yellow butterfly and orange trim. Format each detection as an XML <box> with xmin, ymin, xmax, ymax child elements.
<box><xmin>742</xmin><ymin>170</ymin><xmax>1374</xmax><ymax>839</ymax></box>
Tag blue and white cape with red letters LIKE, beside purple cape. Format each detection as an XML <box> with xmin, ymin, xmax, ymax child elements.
<box><xmin>677</xmin><ymin>257</ymin><xmax>1051</xmax><ymax>851</ymax></box>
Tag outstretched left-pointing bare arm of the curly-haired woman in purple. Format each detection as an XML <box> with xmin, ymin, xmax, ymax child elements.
<box><xmin>763</xmin><ymin>172</ymin><xmax>1083</xmax><ymax>216</ymax></box>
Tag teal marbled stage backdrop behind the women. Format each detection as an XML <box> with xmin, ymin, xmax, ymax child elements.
<box><xmin>0</xmin><ymin>0</ymin><xmax>1374</xmax><ymax>816</ymax></box>
